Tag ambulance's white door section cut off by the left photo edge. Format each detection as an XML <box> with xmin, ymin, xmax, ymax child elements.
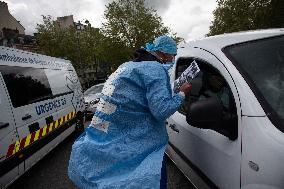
<box><xmin>0</xmin><ymin>71</ymin><xmax>18</xmax><ymax>188</ymax></box>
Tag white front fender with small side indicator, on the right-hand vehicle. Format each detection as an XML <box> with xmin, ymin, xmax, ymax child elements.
<box><xmin>241</xmin><ymin>116</ymin><xmax>284</xmax><ymax>188</ymax></box>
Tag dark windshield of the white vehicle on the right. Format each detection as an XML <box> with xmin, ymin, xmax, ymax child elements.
<box><xmin>225</xmin><ymin>35</ymin><xmax>284</xmax><ymax>120</ymax></box>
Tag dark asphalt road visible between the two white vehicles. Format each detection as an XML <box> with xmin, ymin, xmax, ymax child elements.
<box><xmin>8</xmin><ymin>122</ymin><xmax>194</xmax><ymax>189</ymax></box>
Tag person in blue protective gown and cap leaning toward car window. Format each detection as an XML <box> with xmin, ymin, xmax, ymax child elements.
<box><xmin>68</xmin><ymin>36</ymin><xmax>191</xmax><ymax>189</ymax></box>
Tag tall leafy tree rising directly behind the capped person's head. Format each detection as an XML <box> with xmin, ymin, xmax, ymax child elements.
<box><xmin>102</xmin><ymin>0</ymin><xmax>181</xmax><ymax>66</ymax></box>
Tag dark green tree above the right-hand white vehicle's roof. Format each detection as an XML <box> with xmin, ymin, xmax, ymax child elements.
<box><xmin>207</xmin><ymin>0</ymin><xmax>284</xmax><ymax>36</ymax></box>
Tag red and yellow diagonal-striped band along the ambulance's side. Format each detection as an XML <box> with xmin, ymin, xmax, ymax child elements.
<box><xmin>6</xmin><ymin>112</ymin><xmax>76</xmax><ymax>158</ymax></box>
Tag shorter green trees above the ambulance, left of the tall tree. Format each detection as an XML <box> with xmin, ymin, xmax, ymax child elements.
<box><xmin>37</xmin><ymin>16</ymin><xmax>102</xmax><ymax>68</ymax></box>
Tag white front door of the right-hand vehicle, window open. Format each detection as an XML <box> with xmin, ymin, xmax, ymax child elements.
<box><xmin>167</xmin><ymin>48</ymin><xmax>241</xmax><ymax>189</ymax></box>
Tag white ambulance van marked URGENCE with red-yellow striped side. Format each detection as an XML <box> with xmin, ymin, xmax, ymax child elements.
<box><xmin>0</xmin><ymin>47</ymin><xmax>84</xmax><ymax>188</ymax></box>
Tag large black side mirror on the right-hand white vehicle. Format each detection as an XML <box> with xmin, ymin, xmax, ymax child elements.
<box><xmin>186</xmin><ymin>97</ymin><xmax>222</xmax><ymax>131</ymax></box>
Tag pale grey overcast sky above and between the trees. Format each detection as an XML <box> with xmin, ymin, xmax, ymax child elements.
<box><xmin>4</xmin><ymin>0</ymin><xmax>217</xmax><ymax>41</ymax></box>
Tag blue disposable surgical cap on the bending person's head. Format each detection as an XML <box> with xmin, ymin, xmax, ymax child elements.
<box><xmin>146</xmin><ymin>35</ymin><xmax>177</xmax><ymax>55</ymax></box>
